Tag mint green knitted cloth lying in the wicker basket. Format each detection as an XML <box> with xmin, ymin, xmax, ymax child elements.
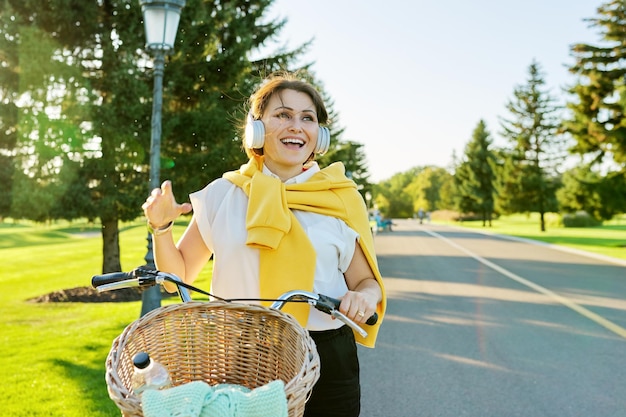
<box><xmin>141</xmin><ymin>380</ymin><xmax>287</xmax><ymax>417</ymax></box>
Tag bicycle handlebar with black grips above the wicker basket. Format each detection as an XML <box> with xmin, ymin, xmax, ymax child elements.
<box><xmin>91</xmin><ymin>267</ymin><xmax>378</xmax><ymax>337</ymax></box>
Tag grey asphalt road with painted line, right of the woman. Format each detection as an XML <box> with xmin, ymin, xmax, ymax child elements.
<box><xmin>359</xmin><ymin>220</ymin><xmax>626</xmax><ymax>417</ymax></box>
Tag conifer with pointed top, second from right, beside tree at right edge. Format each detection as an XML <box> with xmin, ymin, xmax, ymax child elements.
<box><xmin>496</xmin><ymin>61</ymin><xmax>565</xmax><ymax>231</ymax></box>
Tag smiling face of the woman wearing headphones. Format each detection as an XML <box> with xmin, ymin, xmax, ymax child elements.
<box><xmin>261</xmin><ymin>89</ymin><xmax>319</xmax><ymax>181</ymax></box>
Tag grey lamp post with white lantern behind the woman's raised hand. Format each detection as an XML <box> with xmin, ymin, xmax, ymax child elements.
<box><xmin>139</xmin><ymin>0</ymin><xmax>185</xmax><ymax>316</ymax></box>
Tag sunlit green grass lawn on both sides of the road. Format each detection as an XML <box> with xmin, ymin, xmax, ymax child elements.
<box><xmin>0</xmin><ymin>216</ymin><xmax>626</xmax><ymax>417</ymax></box>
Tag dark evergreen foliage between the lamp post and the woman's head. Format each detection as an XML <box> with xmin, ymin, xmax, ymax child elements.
<box><xmin>158</xmin><ymin>0</ymin><xmax>301</xmax><ymax>198</ymax></box>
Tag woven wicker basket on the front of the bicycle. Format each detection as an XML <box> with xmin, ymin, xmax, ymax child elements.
<box><xmin>106</xmin><ymin>301</ymin><xmax>320</xmax><ymax>417</ymax></box>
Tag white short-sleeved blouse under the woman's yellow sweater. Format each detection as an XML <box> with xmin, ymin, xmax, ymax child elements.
<box><xmin>189</xmin><ymin>163</ymin><xmax>358</xmax><ymax>330</ymax></box>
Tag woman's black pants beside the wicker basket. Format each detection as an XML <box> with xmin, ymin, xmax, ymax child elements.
<box><xmin>304</xmin><ymin>326</ymin><xmax>361</xmax><ymax>417</ymax></box>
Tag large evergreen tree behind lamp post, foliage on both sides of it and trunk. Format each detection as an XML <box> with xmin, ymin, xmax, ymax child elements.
<box><xmin>0</xmin><ymin>0</ymin><xmax>299</xmax><ymax>272</ymax></box>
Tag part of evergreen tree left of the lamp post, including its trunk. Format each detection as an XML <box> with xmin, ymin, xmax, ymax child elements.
<box><xmin>0</xmin><ymin>0</ymin><xmax>149</xmax><ymax>266</ymax></box>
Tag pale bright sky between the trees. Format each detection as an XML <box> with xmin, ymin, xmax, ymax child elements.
<box><xmin>268</xmin><ymin>0</ymin><xmax>603</xmax><ymax>182</ymax></box>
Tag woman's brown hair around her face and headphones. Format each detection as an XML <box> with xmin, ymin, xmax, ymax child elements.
<box><xmin>243</xmin><ymin>72</ymin><xmax>328</xmax><ymax>157</ymax></box>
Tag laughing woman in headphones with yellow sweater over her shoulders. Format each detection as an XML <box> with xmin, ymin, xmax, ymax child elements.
<box><xmin>143</xmin><ymin>74</ymin><xmax>386</xmax><ymax>417</ymax></box>
